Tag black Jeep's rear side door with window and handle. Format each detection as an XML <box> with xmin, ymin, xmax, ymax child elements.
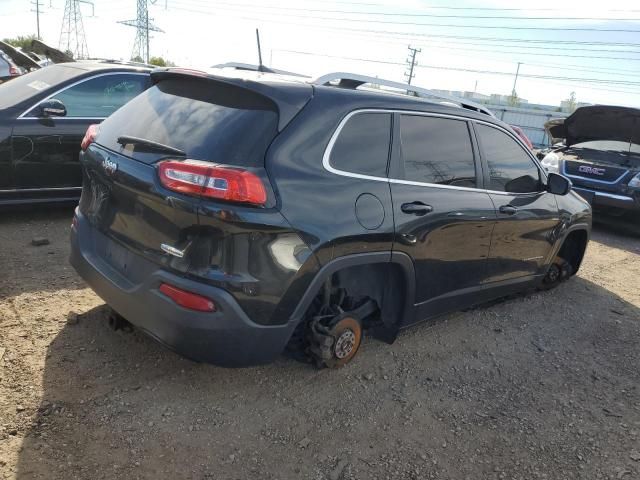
<box><xmin>390</xmin><ymin>113</ymin><xmax>496</xmax><ymax>321</ymax></box>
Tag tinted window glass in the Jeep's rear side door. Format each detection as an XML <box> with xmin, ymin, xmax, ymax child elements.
<box><xmin>400</xmin><ymin>115</ymin><xmax>477</xmax><ymax>188</ymax></box>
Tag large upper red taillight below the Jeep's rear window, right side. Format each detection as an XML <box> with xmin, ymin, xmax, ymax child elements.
<box><xmin>158</xmin><ymin>160</ymin><xmax>267</xmax><ymax>205</ymax></box>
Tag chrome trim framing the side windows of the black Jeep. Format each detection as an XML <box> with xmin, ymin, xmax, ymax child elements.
<box><xmin>322</xmin><ymin>108</ymin><xmax>546</xmax><ymax>196</ymax></box>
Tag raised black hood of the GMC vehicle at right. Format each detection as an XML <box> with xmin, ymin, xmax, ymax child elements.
<box><xmin>544</xmin><ymin>105</ymin><xmax>640</xmax><ymax>146</ymax></box>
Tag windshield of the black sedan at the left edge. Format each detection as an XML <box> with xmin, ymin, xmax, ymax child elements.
<box><xmin>0</xmin><ymin>65</ymin><xmax>86</xmax><ymax>109</ymax></box>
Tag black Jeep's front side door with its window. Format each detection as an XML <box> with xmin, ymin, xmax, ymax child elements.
<box><xmin>475</xmin><ymin>123</ymin><xmax>560</xmax><ymax>281</ymax></box>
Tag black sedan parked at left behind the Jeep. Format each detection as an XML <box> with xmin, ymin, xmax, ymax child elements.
<box><xmin>0</xmin><ymin>60</ymin><xmax>151</xmax><ymax>205</ymax></box>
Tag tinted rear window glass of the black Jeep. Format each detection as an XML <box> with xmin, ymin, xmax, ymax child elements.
<box><xmin>97</xmin><ymin>77</ymin><xmax>278</xmax><ymax>167</ymax></box>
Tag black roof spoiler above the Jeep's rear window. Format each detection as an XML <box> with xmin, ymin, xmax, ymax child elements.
<box><xmin>151</xmin><ymin>68</ymin><xmax>313</xmax><ymax>131</ymax></box>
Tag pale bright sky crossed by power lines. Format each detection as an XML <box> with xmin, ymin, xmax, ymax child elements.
<box><xmin>0</xmin><ymin>0</ymin><xmax>640</xmax><ymax>107</ymax></box>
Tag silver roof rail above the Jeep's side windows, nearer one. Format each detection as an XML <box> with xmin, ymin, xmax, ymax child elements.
<box><xmin>311</xmin><ymin>72</ymin><xmax>495</xmax><ymax>117</ymax></box>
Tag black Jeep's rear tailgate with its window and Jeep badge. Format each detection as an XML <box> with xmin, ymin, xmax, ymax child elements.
<box><xmin>80</xmin><ymin>72</ymin><xmax>310</xmax><ymax>280</ymax></box>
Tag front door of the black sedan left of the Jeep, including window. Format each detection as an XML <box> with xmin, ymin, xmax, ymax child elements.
<box><xmin>12</xmin><ymin>72</ymin><xmax>149</xmax><ymax>189</ymax></box>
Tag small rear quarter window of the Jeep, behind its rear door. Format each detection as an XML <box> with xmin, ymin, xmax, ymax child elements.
<box><xmin>330</xmin><ymin>113</ymin><xmax>391</xmax><ymax>177</ymax></box>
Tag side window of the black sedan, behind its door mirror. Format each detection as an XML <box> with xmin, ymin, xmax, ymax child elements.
<box><xmin>33</xmin><ymin>74</ymin><xmax>148</xmax><ymax>118</ymax></box>
